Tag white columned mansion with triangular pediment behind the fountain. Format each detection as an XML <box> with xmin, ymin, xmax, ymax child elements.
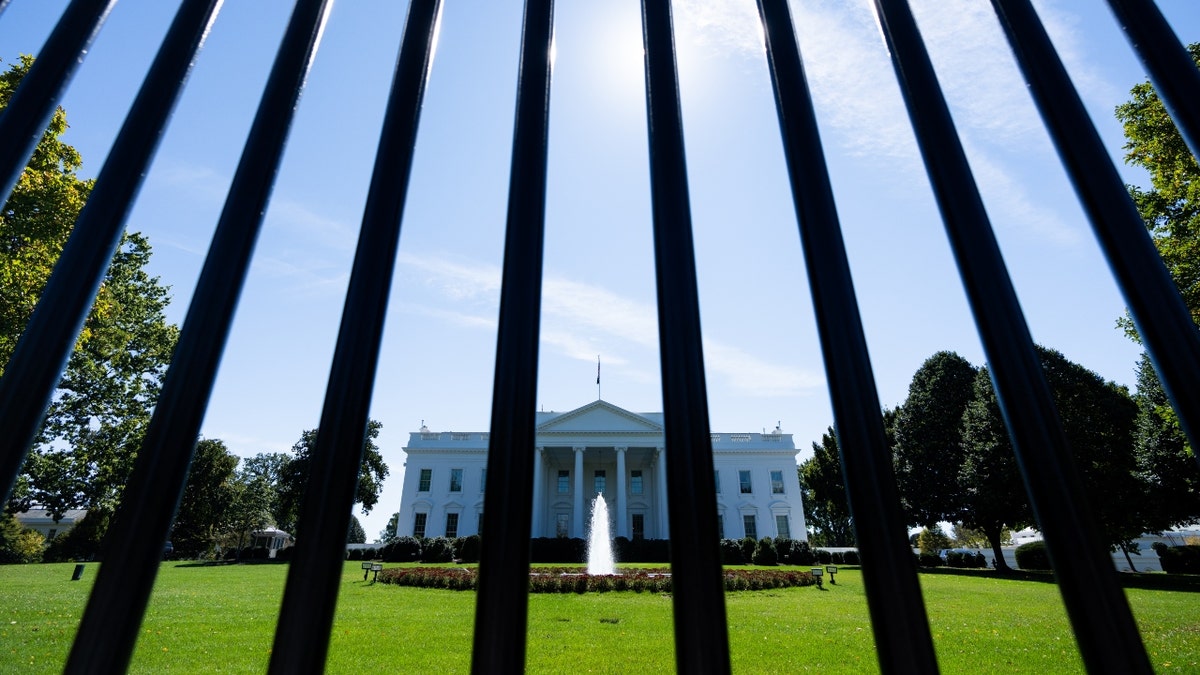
<box><xmin>397</xmin><ymin>400</ymin><xmax>808</xmax><ymax>539</ymax></box>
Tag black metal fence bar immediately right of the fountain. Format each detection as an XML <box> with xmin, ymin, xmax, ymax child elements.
<box><xmin>642</xmin><ymin>0</ymin><xmax>730</xmax><ymax>673</ymax></box>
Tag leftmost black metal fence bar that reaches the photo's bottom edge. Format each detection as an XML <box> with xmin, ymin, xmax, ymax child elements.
<box><xmin>68</xmin><ymin>2</ymin><xmax>324</xmax><ymax>671</ymax></box>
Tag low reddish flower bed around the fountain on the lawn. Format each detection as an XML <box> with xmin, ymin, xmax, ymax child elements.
<box><xmin>379</xmin><ymin>567</ymin><xmax>815</xmax><ymax>593</ymax></box>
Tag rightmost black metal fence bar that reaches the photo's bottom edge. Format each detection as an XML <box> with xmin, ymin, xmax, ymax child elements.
<box><xmin>875</xmin><ymin>0</ymin><xmax>1150</xmax><ymax>673</ymax></box>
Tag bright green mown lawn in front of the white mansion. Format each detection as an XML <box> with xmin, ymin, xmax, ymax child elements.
<box><xmin>0</xmin><ymin>562</ymin><xmax>1200</xmax><ymax>674</ymax></box>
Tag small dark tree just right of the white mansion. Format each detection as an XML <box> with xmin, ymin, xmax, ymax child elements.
<box><xmin>796</xmin><ymin>426</ymin><xmax>854</xmax><ymax>546</ymax></box>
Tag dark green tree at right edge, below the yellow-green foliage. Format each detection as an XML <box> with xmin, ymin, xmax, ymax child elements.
<box><xmin>1134</xmin><ymin>353</ymin><xmax>1200</xmax><ymax>532</ymax></box>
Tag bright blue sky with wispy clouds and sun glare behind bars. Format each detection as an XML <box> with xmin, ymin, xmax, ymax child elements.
<box><xmin>0</xmin><ymin>0</ymin><xmax>1200</xmax><ymax>537</ymax></box>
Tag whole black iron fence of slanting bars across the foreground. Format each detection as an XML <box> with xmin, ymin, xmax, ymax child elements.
<box><xmin>0</xmin><ymin>0</ymin><xmax>1200</xmax><ymax>673</ymax></box>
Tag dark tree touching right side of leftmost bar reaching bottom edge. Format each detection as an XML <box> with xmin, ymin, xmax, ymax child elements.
<box><xmin>170</xmin><ymin>438</ymin><xmax>238</xmax><ymax>557</ymax></box>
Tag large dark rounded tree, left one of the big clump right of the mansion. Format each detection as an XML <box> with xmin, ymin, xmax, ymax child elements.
<box><xmin>893</xmin><ymin>352</ymin><xmax>976</xmax><ymax>528</ymax></box>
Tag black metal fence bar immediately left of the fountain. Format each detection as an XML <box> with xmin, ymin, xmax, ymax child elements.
<box><xmin>470</xmin><ymin>0</ymin><xmax>554</xmax><ymax>673</ymax></box>
